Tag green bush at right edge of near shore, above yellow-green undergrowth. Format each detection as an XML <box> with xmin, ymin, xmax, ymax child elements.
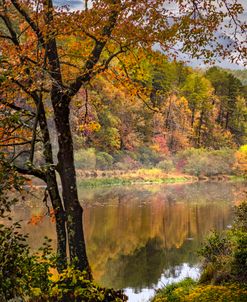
<box><xmin>200</xmin><ymin>202</ymin><xmax>247</xmax><ymax>284</ymax></box>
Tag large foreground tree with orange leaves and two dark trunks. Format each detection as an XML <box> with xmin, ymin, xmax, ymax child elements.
<box><xmin>0</xmin><ymin>0</ymin><xmax>246</xmax><ymax>271</ymax></box>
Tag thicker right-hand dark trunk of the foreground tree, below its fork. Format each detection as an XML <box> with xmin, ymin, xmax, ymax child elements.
<box><xmin>52</xmin><ymin>95</ymin><xmax>91</xmax><ymax>278</ymax></box>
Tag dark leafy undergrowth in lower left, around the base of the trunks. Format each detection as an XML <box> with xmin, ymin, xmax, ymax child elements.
<box><xmin>0</xmin><ymin>223</ymin><xmax>127</xmax><ymax>302</ymax></box>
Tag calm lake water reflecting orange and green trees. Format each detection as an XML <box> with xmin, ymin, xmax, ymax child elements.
<box><xmin>6</xmin><ymin>183</ymin><xmax>243</xmax><ymax>302</ymax></box>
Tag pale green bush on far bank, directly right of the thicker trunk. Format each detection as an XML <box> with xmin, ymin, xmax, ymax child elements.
<box><xmin>75</xmin><ymin>148</ymin><xmax>96</xmax><ymax>170</ymax></box>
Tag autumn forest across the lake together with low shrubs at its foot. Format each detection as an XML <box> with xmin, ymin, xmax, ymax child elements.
<box><xmin>72</xmin><ymin>62</ymin><xmax>247</xmax><ymax>176</ymax></box>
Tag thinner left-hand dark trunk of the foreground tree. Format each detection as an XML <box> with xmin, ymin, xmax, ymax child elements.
<box><xmin>39</xmin><ymin>102</ymin><xmax>67</xmax><ymax>272</ymax></box>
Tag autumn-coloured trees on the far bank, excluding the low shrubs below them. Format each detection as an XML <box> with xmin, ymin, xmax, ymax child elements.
<box><xmin>72</xmin><ymin>53</ymin><xmax>247</xmax><ymax>154</ymax></box>
